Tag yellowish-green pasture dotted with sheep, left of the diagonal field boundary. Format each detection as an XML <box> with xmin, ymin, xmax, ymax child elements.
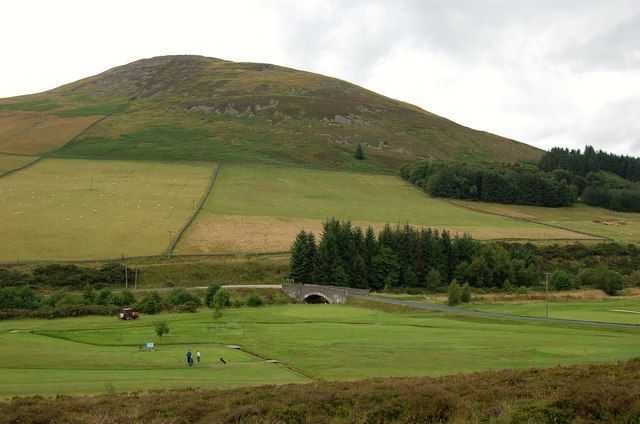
<box><xmin>0</xmin><ymin>159</ymin><xmax>213</xmax><ymax>262</ymax></box>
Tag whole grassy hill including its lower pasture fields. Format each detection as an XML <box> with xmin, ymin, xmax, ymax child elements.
<box><xmin>5</xmin><ymin>56</ymin><xmax>624</xmax><ymax>262</ymax></box>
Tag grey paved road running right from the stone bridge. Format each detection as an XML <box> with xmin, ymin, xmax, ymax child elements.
<box><xmin>353</xmin><ymin>295</ymin><xmax>640</xmax><ymax>329</ymax></box>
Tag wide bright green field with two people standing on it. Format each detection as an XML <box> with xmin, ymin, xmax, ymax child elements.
<box><xmin>0</xmin><ymin>305</ymin><xmax>638</xmax><ymax>397</ymax></box>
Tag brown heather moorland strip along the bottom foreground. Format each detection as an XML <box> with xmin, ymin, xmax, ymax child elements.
<box><xmin>0</xmin><ymin>359</ymin><xmax>640</xmax><ymax>424</ymax></box>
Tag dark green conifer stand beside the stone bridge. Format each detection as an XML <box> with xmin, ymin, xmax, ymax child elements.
<box><xmin>290</xmin><ymin>219</ymin><xmax>539</xmax><ymax>290</ymax></box>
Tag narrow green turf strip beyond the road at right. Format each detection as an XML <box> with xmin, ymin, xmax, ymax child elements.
<box><xmin>466</xmin><ymin>299</ymin><xmax>640</xmax><ymax>325</ymax></box>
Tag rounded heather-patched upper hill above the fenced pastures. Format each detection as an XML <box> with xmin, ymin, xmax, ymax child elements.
<box><xmin>0</xmin><ymin>56</ymin><xmax>541</xmax><ymax>172</ymax></box>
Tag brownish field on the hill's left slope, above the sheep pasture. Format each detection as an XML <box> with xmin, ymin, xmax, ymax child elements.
<box><xmin>0</xmin><ymin>108</ymin><xmax>99</xmax><ymax>155</ymax></box>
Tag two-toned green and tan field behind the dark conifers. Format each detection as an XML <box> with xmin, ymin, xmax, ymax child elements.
<box><xmin>176</xmin><ymin>164</ymin><xmax>585</xmax><ymax>253</ymax></box>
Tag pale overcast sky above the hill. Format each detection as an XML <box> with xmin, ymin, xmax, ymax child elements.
<box><xmin>0</xmin><ymin>0</ymin><xmax>640</xmax><ymax>155</ymax></box>
